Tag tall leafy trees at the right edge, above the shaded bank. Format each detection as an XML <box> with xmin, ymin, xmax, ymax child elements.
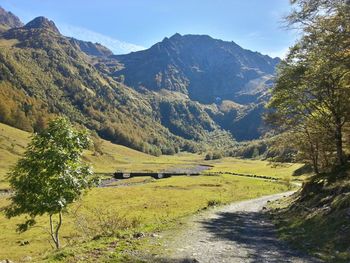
<box><xmin>269</xmin><ymin>0</ymin><xmax>350</xmax><ymax>172</ymax></box>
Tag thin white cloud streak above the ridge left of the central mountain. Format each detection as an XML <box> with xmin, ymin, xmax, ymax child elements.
<box><xmin>57</xmin><ymin>24</ymin><xmax>145</xmax><ymax>54</ymax></box>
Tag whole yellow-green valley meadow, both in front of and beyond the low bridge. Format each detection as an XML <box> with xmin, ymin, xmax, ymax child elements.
<box><xmin>0</xmin><ymin>124</ymin><xmax>299</xmax><ymax>262</ymax></box>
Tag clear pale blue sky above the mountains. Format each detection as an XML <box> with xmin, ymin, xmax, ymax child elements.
<box><xmin>0</xmin><ymin>0</ymin><xmax>297</xmax><ymax>57</ymax></box>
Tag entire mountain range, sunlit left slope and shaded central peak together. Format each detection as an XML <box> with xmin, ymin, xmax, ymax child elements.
<box><xmin>0</xmin><ymin>6</ymin><xmax>280</xmax><ymax>155</ymax></box>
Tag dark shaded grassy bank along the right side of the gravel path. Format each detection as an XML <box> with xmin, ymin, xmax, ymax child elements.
<box><xmin>271</xmin><ymin>167</ymin><xmax>350</xmax><ymax>263</ymax></box>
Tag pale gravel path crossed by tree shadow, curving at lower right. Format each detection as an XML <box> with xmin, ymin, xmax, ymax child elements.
<box><xmin>171</xmin><ymin>192</ymin><xmax>320</xmax><ymax>263</ymax></box>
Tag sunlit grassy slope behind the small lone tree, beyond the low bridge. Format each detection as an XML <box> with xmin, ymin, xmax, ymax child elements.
<box><xmin>0</xmin><ymin>123</ymin><xmax>203</xmax><ymax>189</ymax></box>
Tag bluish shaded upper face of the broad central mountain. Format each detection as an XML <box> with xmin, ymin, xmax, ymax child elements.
<box><xmin>112</xmin><ymin>34</ymin><xmax>280</xmax><ymax>103</ymax></box>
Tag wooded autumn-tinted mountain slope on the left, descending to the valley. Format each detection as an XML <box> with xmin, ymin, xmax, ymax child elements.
<box><xmin>0</xmin><ymin>14</ymin><xmax>237</xmax><ymax>155</ymax></box>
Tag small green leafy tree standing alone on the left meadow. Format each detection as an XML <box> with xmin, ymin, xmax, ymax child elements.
<box><xmin>5</xmin><ymin>118</ymin><xmax>95</xmax><ymax>249</ymax></box>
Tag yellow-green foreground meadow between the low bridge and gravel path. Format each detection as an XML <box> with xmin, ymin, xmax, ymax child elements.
<box><xmin>0</xmin><ymin>175</ymin><xmax>288</xmax><ymax>262</ymax></box>
